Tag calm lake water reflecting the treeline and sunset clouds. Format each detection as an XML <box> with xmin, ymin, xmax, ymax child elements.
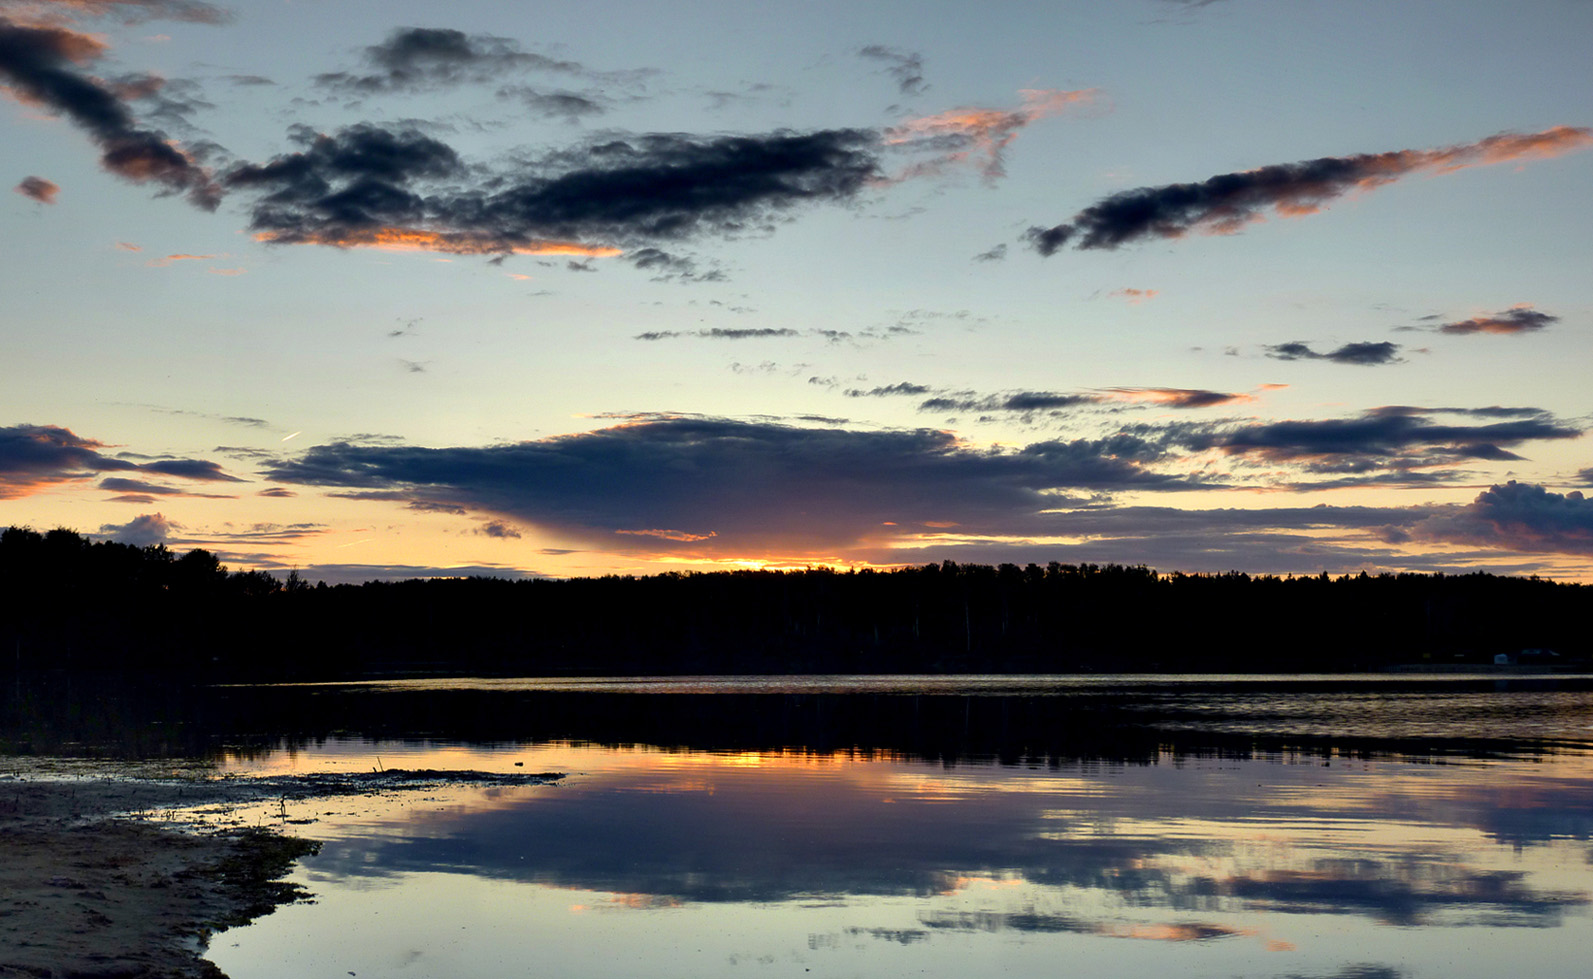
<box><xmin>171</xmin><ymin>678</ymin><xmax>1593</xmax><ymax>979</ymax></box>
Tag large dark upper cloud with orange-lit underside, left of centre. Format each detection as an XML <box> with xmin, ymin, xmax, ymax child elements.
<box><xmin>226</xmin><ymin>124</ymin><xmax>878</xmax><ymax>255</ymax></box>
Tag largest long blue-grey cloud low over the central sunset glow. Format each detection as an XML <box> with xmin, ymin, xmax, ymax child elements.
<box><xmin>266</xmin><ymin>417</ymin><xmax>1203</xmax><ymax>554</ymax></box>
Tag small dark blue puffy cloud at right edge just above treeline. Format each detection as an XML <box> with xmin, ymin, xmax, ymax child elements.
<box><xmin>1415</xmin><ymin>479</ymin><xmax>1593</xmax><ymax>554</ymax></box>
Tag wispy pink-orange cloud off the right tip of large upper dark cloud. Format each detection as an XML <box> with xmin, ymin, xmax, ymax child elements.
<box><xmin>884</xmin><ymin>89</ymin><xmax>1096</xmax><ymax>180</ymax></box>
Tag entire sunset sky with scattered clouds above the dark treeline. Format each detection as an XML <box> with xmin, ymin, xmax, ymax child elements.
<box><xmin>0</xmin><ymin>0</ymin><xmax>1593</xmax><ymax>583</ymax></box>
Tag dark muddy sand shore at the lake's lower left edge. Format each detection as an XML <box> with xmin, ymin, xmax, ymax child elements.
<box><xmin>0</xmin><ymin>758</ymin><xmax>561</xmax><ymax>979</ymax></box>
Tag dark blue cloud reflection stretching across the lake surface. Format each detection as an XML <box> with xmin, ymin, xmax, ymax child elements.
<box><xmin>293</xmin><ymin>755</ymin><xmax>1593</xmax><ymax>941</ymax></box>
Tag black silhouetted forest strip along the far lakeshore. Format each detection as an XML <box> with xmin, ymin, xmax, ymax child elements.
<box><xmin>0</xmin><ymin>527</ymin><xmax>1593</xmax><ymax>681</ymax></box>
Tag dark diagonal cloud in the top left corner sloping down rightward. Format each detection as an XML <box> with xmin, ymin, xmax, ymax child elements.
<box><xmin>0</xmin><ymin>18</ymin><xmax>220</xmax><ymax>210</ymax></box>
